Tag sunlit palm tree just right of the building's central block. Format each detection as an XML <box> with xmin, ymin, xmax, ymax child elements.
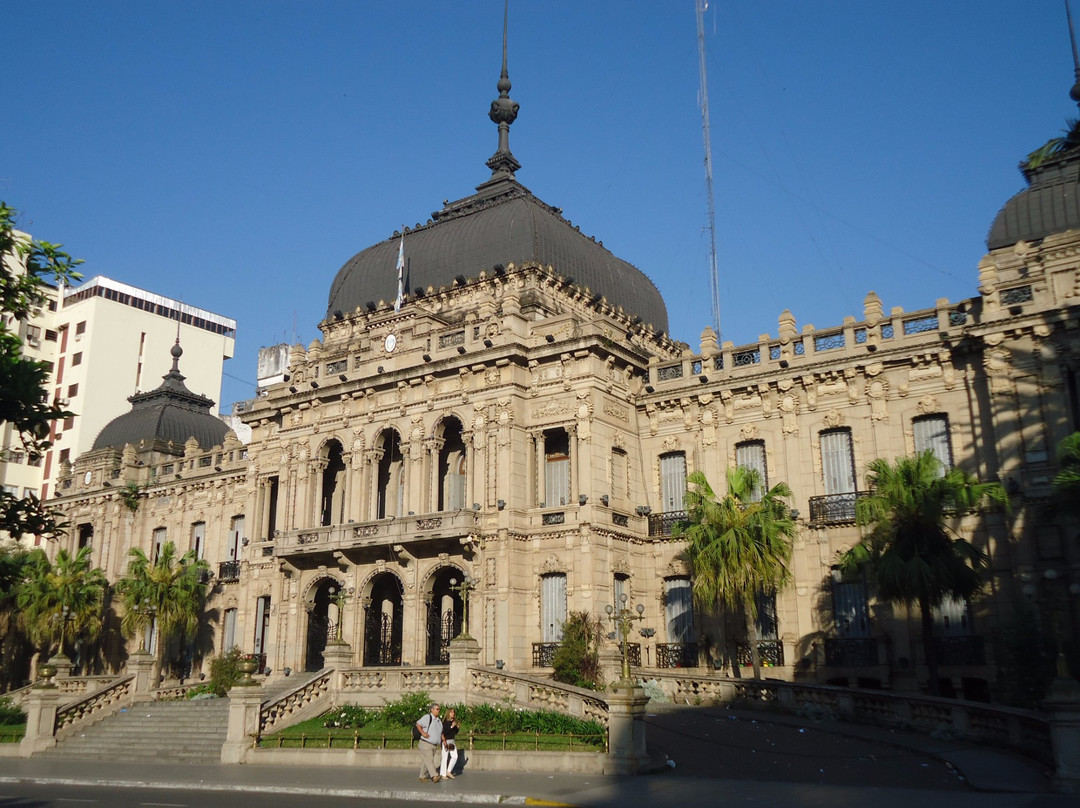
<box><xmin>673</xmin><ymin>467</ymin><xmax>797</xmax><ymax>679</ymax></box>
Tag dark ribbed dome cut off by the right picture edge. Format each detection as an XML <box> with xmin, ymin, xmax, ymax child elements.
<box><xmin>986</xmin><ymin>150</ymin><xmax>1080</xmax><ymax>250</ymax></box>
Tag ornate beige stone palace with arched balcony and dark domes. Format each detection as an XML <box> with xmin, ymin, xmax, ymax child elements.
<box><xmin>46</xmin><ymin>47</ymin><xmax>1080</xmax><ymax>697</ymax></box>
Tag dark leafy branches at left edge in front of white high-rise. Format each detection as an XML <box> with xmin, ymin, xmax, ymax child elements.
<box><xmin>0</xmin><ymin>202</ymin><xmax>82</xmax><ymax>538</ymax></box>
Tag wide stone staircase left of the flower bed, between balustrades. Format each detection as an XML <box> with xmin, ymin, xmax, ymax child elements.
<box><xmin>36</xmin><ymin>699</ymin><xmax>229</xmax><ymax>764</ymax></box>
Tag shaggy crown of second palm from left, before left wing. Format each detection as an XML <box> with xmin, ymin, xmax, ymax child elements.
<box><xmin>116</xmin><ymin>541</ymin><xmax>210</xmax><ymax>670</ymax></box>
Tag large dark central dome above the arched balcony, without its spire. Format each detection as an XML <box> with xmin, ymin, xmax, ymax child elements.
<box><xmin>326</xmin><ymin>178</ymin><xmax>667</xmax><ymax>332</ymax></box>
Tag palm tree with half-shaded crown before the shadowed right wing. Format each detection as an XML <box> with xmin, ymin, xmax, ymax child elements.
<box><xmin>841</xmin><ymin>449</ymin><xmax>1009</xmax><ymax>696</ymax></box>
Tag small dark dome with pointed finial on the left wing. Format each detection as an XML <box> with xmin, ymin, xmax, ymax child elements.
<box><xmin>93</xmin><ymin>342</ymin><xmax>229</xmax><ymax>449</ymax></box>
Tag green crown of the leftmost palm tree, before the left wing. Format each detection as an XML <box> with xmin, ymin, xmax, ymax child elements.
<box><xmin>15</xmin><ymin>546</ymin><xmax>109</xmax><ymax>656</ymax></box>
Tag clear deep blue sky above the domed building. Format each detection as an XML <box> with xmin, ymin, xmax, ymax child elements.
<box><xmin>0</xmin><ymin>0</ymin><xmax>1077</xmax><ymax>406</ymax></box>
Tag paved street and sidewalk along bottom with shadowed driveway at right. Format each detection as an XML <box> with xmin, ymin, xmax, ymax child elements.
<box><xmin>0</xmin><ymin>709</ymin><xmax>1067</xmax><ymax>808</ymax></box>
